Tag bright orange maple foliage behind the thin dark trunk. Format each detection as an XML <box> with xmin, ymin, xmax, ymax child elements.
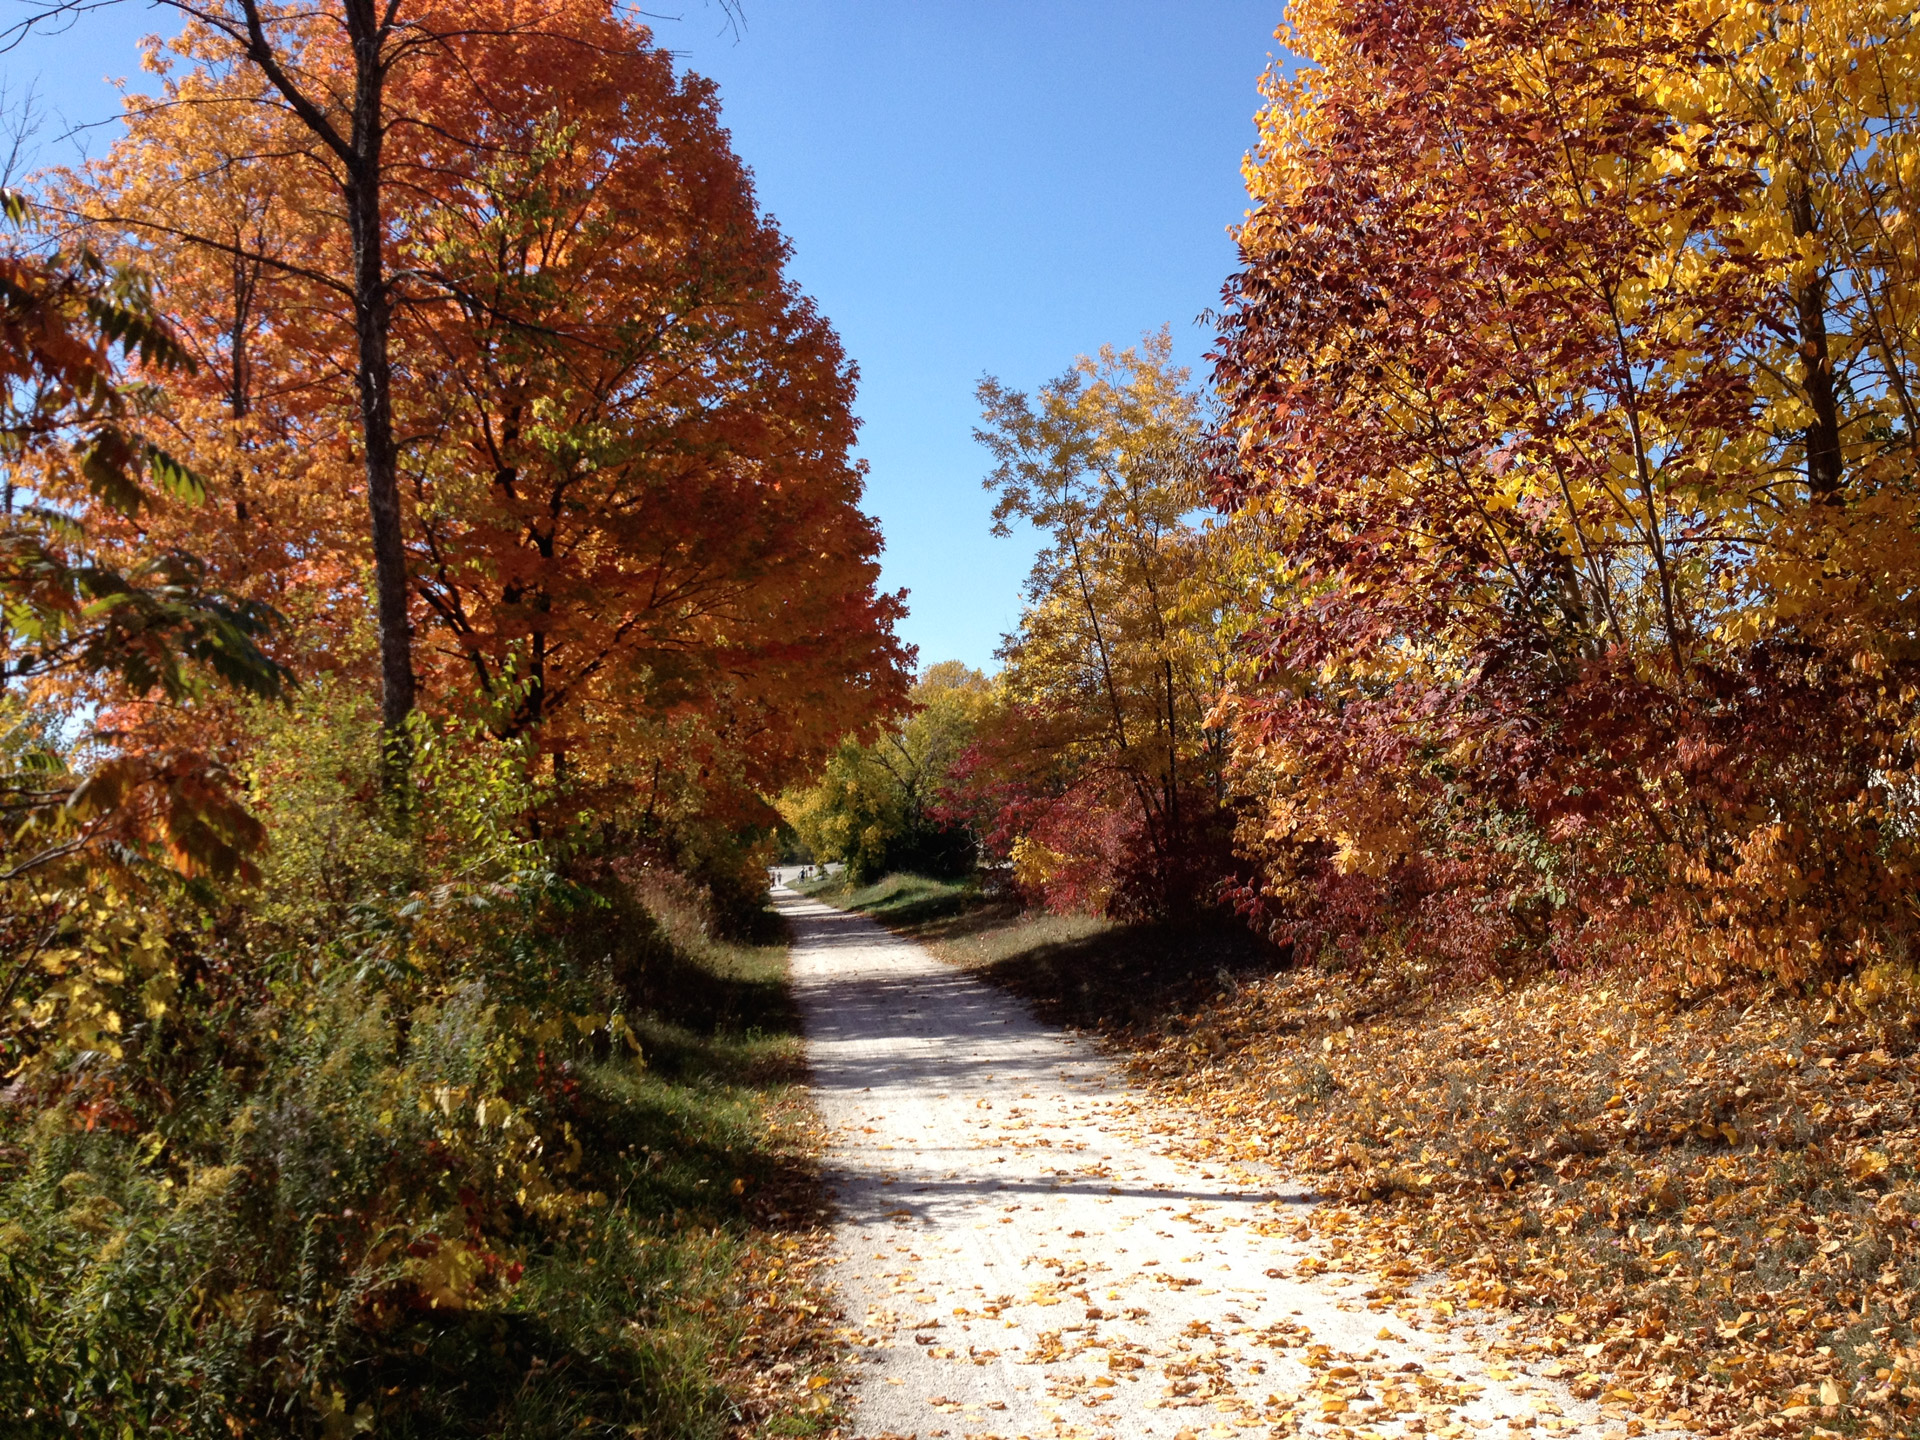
<box><xmin>61</xmin><ymin>0</ymin><xmax>904</xmax><ymax>829</ymax></box>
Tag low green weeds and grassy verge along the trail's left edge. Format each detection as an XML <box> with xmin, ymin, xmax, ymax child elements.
<box><xmin>0</xmin><ymin>885</ymin><xmax>833</xmax><ymax>1440</ymax></box>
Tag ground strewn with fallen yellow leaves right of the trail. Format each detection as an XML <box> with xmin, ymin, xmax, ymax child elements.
<box><xmin>925</xmin><ymin>920</ymin><xmax>1920</xmax><ymax>1436</ymax></box>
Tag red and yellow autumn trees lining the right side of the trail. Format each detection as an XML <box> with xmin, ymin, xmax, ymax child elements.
<box><xmin>798</xmin><ymin>0</ymin><xmax>1920</xmax><ymax>987</ymax></box>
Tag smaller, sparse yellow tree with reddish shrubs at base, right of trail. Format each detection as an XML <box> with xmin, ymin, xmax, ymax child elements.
<box><xmin>954</xmin><ymin>332</ymin><xmax>1233</xmax><ymax>916</ymax></box>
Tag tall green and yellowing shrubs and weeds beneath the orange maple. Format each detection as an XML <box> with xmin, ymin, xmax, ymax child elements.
<box><xmin>0</xmin><ymin>689</ymin><xmax>817</xmax><ymax>1440</ymax></box>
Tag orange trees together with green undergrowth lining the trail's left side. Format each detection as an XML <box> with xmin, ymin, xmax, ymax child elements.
<box><xmin>0</xmin><ymin>0</ymin><xmax>910</xmax><ymax>1436</ymax></box>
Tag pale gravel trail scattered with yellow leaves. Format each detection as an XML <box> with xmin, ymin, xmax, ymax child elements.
<box><xmin>774</xmin><ymin>889</ymin><xmax>1622</xmax><ymax>1440</ymax></box>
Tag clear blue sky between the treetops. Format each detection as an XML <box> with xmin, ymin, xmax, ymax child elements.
<box><xmin>0</xmin><ymin>0</ymin><xmax>1283</xmax><ymax>668</ymax></box>
